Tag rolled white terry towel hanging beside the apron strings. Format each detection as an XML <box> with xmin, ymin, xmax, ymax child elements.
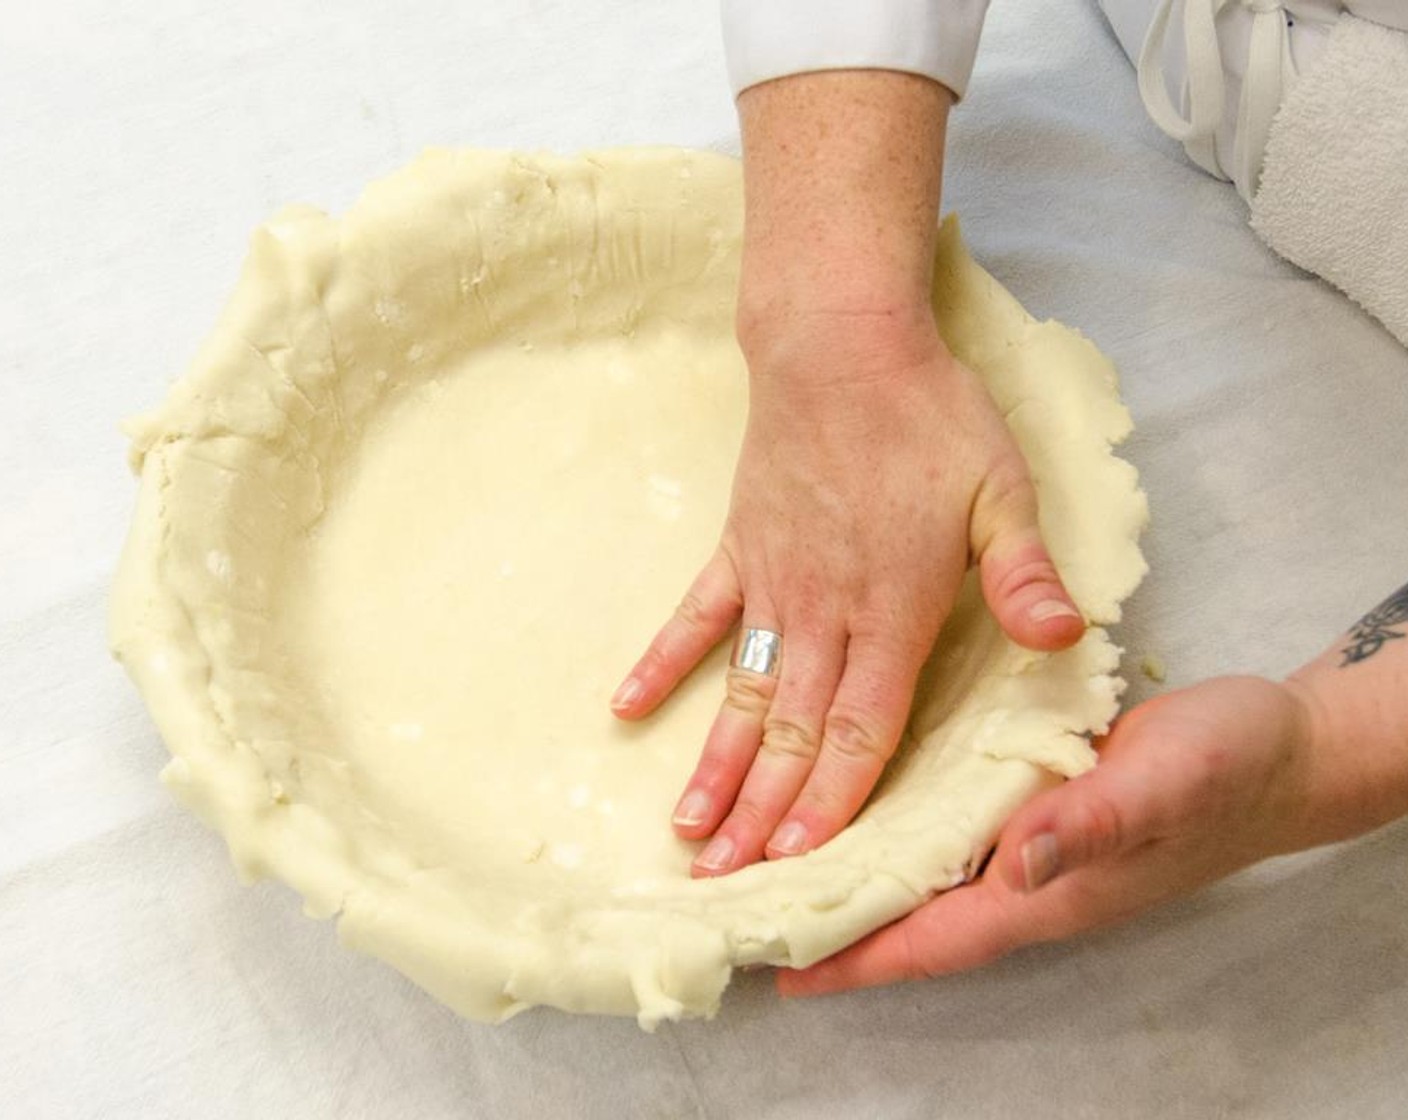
<box><xmin>1252</xmin><ymin>15</ymin><xmax>1408</xmax><ymax>347</ymax></box>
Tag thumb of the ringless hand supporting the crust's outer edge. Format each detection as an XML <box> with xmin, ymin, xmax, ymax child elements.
<box><xmin>993</xmin><ymin>759</ymin><xmax>1159</xmax><ymax>893</ymax></box>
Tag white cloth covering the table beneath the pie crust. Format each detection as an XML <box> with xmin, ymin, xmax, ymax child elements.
<box><xmin>0</xmin><ymin>0</ymin><xmax>1408</xmax><ymax>1120</ymax></box>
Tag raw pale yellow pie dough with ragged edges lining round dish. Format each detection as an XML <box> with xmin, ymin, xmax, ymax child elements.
<box><xmin>113</xmin><ymin>149</ymin><xmax>1146</xmax><ymax>1027</ymax></box>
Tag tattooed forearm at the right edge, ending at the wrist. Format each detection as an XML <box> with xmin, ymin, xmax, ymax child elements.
<box><xmin>1288</xmin><ymin>586</ymin><xmax>1408</xmax><ymax>842</ymax></box>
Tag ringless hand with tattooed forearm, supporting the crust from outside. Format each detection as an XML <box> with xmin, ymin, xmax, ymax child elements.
<box><xmin>777</xmin><ymin>586</ymin><xmax>1408</xmax><ymax>996</ymax></box>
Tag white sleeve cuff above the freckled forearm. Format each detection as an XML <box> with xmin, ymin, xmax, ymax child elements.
<box><xmin>722</xmin><ymin>0</ymin><xmax>987</xmax><ymax>97</ymax></box>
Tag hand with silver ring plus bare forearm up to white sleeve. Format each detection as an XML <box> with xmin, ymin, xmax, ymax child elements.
<box><xmin>612</xmin><ymin>70</ymin><xmax>1084</xmax><ymax>875</ymax></box>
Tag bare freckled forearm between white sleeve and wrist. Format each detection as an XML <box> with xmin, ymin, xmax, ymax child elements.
<box><xmin>738</xmin><ymin>70</ymin><xmax>953</xmax><ymax>352</ymax></box>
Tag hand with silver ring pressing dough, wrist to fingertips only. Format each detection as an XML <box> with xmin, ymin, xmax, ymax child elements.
<box><xmin>617</xmin><ymin>309</ymin><xmax>1084</xmax><ymax>875</ymax></box>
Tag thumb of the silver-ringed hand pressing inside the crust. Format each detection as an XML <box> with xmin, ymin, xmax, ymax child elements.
<box><xmin>970</xmin><ymin>468</ymin><xmax>1086</xmax><ymax>651</ymax></box>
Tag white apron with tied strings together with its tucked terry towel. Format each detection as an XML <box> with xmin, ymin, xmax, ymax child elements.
<box><xmin>1100</xmin><ymin>0</ymin><xmax>1408</xmax><ymax>345</ymax></box>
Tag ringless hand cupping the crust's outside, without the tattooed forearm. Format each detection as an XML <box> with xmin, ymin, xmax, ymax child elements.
<box><xmin>777</xmin><ymin>678</ymin><xmax>1329</xmax><ymax>996</ymax></box>
